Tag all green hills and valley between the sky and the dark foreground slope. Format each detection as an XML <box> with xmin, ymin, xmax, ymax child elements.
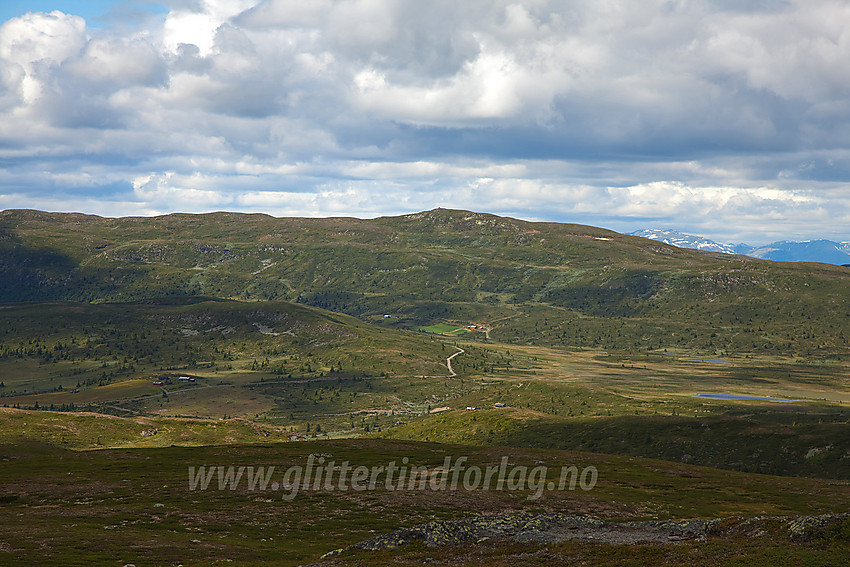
<box><xmin>0</xmin><ymin>209</ymin><xmax>850</xmax><ymax>477</ymax></box>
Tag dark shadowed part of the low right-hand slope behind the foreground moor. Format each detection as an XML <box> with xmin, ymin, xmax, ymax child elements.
<box><xmin>493</xmin><ymin>415</ymin><xmax>850</xmax><ymax>479</ymax></box>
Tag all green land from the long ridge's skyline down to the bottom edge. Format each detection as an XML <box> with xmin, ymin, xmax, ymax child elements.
<box><xmin>0</xmin><ymin>209</ymin><xmax>850</xmax><ymax>567</ymax></box>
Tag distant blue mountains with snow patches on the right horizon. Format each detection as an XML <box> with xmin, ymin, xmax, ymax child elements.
<box><xmin>629</xmin><ymin>228</ymin><xmax>850</xmax><ymax>265</ymax></box>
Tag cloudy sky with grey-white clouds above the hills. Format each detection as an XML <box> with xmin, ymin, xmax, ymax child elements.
<box><xmin>0</xmin><ymin>0</ymin><xmax>850</xmax><ymax>244</ymax></box>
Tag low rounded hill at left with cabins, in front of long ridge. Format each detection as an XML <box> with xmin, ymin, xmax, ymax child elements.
<box><xmin>0</xmin><ymin>298</ymin><xmax>464</xmax><ymax>430</ymax></box>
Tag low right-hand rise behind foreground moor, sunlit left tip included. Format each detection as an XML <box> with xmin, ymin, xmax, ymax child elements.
<box><xmin>381</xmin><ymin>408</ymin><xmax>850</xmax><ymax>479</ymax></box>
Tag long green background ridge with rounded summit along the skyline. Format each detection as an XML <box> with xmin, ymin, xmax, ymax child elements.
<box><xmin>0</xmin><ymin>209</ymin><xmax>850</xmax><ymax>358</ymax></box>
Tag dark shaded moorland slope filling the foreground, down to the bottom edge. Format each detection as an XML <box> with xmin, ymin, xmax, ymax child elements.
<box><xmin>0</xmin><ymin>438</ymin><xmax>850</xmax><ymax>567</ymax></box>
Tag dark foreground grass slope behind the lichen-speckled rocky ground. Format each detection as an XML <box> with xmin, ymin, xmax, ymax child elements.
<box><xmin>0</xmin><ymin>430</ymin><xmax>850</xmax><ymax>566</ymax></box>
